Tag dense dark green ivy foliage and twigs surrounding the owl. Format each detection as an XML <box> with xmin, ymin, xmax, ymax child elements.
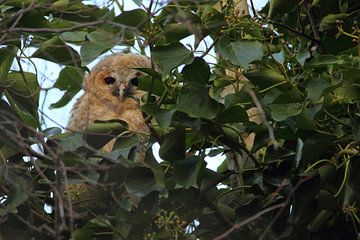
<box><xmin>0</xmin><ymin>0</ymin><xmax>360</xmax><ymax>239</ymax></box>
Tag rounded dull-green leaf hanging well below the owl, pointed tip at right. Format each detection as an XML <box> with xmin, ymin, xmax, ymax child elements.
<box><xmin>124</xmin><ymin>167</ymin><xmax>163</xmax><ymax>198</ymax></box>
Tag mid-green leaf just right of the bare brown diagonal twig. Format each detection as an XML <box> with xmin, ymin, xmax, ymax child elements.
<box><xmin>270</xmin><ymin>103</ymin><xmax>303</xmax><ymax>122</ymax></box>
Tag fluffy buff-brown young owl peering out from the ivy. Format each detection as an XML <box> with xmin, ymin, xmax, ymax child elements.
<box><xmin>67</xmin><ymin>53</ymin><xmax>151</xmax><ymax>161</ymax></box>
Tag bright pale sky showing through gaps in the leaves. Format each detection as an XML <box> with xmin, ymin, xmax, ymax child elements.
<box><xmin>19</xmin><ymin>0</ymin><xmax>267</xmax><ymax>170</ymax></box>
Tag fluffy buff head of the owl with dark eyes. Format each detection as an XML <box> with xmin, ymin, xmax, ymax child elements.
<box><xmin>84</xmin><ymin>53</ymin><xmax>151</xmax><ymax>101</ymax></box>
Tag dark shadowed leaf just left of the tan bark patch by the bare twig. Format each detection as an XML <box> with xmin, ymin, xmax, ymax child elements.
<box><xmin>216</xmin><ymin>105</ymin><xmax>249</xmax><ymax>124</ymax></box>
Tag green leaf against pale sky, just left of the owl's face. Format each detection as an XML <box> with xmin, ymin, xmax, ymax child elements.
<box><xmin>50</xmin><ymin>66</ymin><xmax>85</xmax><ymax>109</ymax></box>
